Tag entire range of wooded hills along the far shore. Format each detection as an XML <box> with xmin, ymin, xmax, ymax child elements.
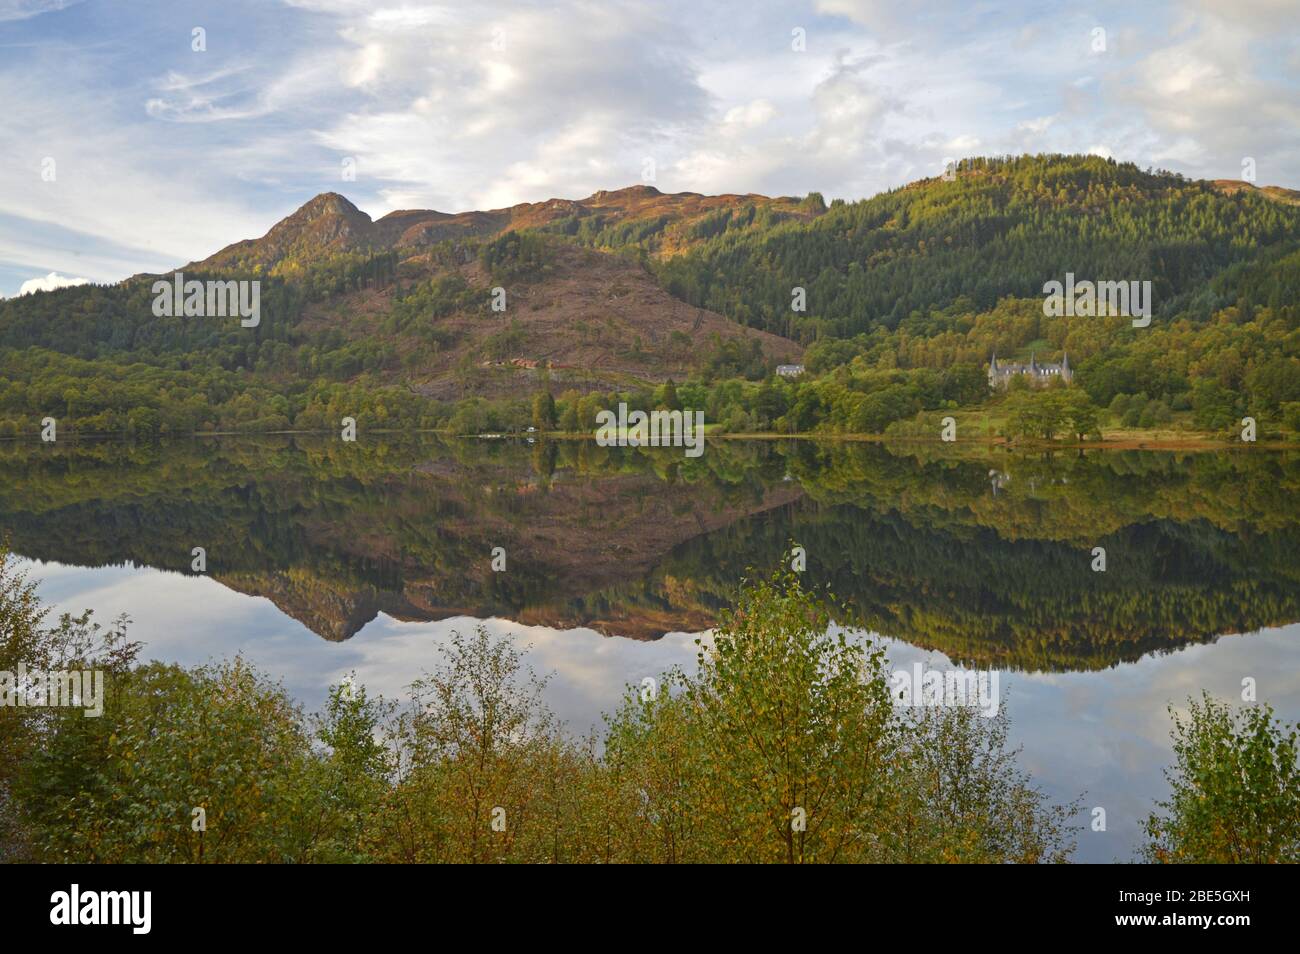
<box><xmin>0</xmin><ymin>156</ymin><xmax>1300</xmax><ymax>439</ymax></box>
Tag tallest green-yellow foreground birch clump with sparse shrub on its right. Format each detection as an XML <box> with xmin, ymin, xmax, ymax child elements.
<box><xmin>607</xmin><ymin>574</ymin><xmax>1074</xmax><ymax>863</ymax></box>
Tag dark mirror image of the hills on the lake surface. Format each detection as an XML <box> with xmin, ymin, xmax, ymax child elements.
<box><xmin>0</xmin><ymin>438</ymin><xmax>1300</xmax><ymax>671</ymax></box>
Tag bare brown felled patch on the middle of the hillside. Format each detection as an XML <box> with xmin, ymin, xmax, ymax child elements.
<box><xmin>289</xmin><ymin>240</ymin><xmax>802</xmax><ymax>400</ymax></box>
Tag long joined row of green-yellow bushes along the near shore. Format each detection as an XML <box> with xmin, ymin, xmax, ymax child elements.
<box><xmin>0</xmin><ymin>561</ymin><xmax>1073</xmax><ymax>862</ymax></box>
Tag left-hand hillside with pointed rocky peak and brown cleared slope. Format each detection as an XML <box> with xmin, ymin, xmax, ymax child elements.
<box><xmin>0</xmin><ymin>187</ymin><xmax>805</xmax><ymax>432</ymax></box>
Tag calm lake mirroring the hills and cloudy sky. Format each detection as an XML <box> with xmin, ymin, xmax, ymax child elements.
<box><xmin>0</xmin><ymin>435</ymin><xmax>1300</xmax><ymax>862</ymax></box>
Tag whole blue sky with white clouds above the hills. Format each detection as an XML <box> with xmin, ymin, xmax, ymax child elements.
<box><xmin>0</xmin><ymin>0</ymin><xmax>1300</xmax><ymax>295</ymax></box>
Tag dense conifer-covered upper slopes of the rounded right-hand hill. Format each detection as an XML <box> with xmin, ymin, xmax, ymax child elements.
<box><xmin>659</xmin><ymin>156</ymin><xmax>1300</xmax><ymax>337</ymax></box>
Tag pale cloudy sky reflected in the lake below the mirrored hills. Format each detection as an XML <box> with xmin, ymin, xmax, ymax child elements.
<box><xmin>17</xmin><ymin>563</ymin><xmax>1300</xmax><ymax>862</ymax></box>
